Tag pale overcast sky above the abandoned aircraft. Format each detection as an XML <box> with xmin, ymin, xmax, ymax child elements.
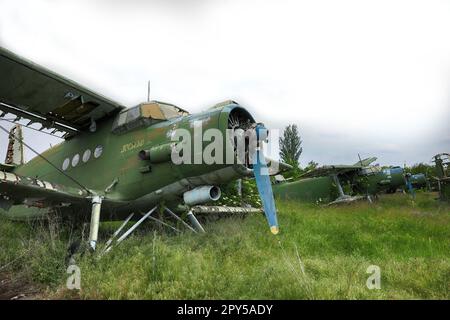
<box><xmin>0</xmin><ymin>0</ymin><xmax>450</xmax><ymax>165</ymax></box>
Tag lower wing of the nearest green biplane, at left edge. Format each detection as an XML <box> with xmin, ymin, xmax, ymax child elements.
<box><xmin>0</xmin><ymin>171</ymin><xmax>89</xmax><ymax>210</ymax></box>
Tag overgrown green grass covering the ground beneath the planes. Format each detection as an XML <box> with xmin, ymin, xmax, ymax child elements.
<box><xmin>0</xmin><ymin>193</ymin><xmax>450</xmax><ymax>299</ymax></box>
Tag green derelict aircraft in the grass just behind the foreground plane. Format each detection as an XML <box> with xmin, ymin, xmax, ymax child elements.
<box><xmin>273</xmin><ymin>157</ymin><xmax>405</xmax><ymax>204</ymax></box>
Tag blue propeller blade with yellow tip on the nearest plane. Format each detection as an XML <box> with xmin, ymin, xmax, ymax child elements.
<box><xmin>253</xmin><ymin>126</ymin><xmax>279</xmax><ymax>234</ymax></box>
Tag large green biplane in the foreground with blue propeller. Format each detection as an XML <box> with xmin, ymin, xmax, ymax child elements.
<box><xmin>0</xmin><ymin>48</ymin><xmax>279</xmax><ymax>249</ymax></box>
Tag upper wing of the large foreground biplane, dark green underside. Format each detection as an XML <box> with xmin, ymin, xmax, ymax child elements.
<box><xmin>0</xmin><ymin>47</ymin><xmax>124</xmax><ymax>135</ymax></box>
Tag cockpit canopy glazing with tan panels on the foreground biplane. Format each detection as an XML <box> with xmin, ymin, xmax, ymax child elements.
<box><xmin>112</xmin><ymin>101</ymin><xmax>189</xmax><ymax>133</ymax></box>
